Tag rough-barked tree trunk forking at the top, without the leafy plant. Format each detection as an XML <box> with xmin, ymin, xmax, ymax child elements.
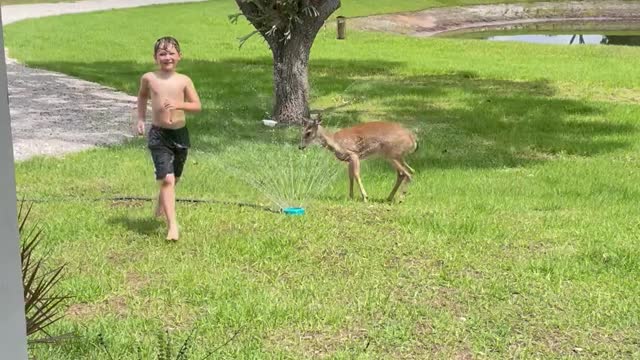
<box><xmin>236</xmin><ymin>0</ymin><xmax>340</xmax><ymax>124</ymax></box>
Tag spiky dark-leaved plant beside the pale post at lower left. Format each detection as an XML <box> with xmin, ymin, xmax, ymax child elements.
<box><xmin>18</xmin><ymin>201</ymin><xmax>70</xmax><ymax>342</ymax></box>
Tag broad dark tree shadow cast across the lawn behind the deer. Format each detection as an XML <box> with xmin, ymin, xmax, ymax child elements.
<box><xmin>30</xmin><ymin>57</ymin><xmax>637</xmax><ymax>169</ymax></box>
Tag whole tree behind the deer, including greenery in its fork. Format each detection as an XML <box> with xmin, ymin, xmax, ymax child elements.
<box><xmin>232</xmin><ymin>0</ymin><xmax>340</xmax><ymax>123</ymax></box>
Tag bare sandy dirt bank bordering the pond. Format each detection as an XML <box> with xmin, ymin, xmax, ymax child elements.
<box><xmin>347</xmin><ymin>1</ymin><xmax>640</xmax><ymax>37</ymax></box>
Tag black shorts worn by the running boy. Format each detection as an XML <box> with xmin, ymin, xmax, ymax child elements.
<box><xmin>148</xmin><ymin>125</ymin><xmax>191</xmax><ymax>180</ymax></box>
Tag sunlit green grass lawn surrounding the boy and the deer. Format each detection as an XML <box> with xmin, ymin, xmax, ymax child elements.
<box><xmin>5</xmin><ymin>2</ymin><xmax>640</xmax><ymax>360</ymax></box>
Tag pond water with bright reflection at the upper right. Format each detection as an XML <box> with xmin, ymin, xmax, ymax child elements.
<box><xmin>438</xmin><ymin>21</ymin><xmax>640</xmax><ymax>46</ymax></box>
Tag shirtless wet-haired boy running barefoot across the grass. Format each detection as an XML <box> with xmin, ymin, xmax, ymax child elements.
<box><xmin>137</xmin><ymin>36</ymin><xmax>201</xmax><ymax>241</ymax></box>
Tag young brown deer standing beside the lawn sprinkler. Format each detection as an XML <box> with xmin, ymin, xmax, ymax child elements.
<box><xmin>299</xmin><ymin>115</ymin><xmax>418</xmax><ymax>201</ymax></box>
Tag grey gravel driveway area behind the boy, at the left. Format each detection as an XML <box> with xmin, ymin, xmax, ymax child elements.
<box><xmin>7</xmin><ymin>59</ymin><xmax>136</xmax><ymax>161</ymax></box>
